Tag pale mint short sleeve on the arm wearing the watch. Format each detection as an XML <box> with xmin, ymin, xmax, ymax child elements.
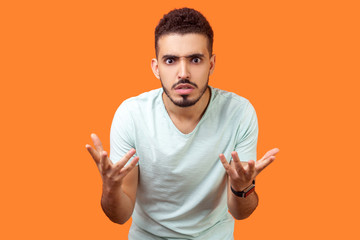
<box><xmin>234</xmin><ymin>101</ymin><xmax>259</xmax><ymax>162</ymax></box>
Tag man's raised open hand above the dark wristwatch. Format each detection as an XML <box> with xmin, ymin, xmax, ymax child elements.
<box><xmin>219</xmin><ymin>148</ymin><xmax>279</xmax><ymax>191</ymax></box>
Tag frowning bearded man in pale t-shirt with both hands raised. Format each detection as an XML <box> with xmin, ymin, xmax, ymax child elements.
<box><xmin>86</xmin><ymin>8</ymin><xmax>278</xmax><ymax>240</ymax></box>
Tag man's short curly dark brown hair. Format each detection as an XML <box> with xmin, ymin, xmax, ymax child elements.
<box><xmin>155</xmin><ymin>8</ymin><xmax>214</xmax><ymax>57</ymax></box>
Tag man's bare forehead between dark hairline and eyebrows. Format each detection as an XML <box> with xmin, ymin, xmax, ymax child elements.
<box><xmin>158</xmin><ymin>33</ymin><xmax>209</xmax><ymax>57</ymax></box>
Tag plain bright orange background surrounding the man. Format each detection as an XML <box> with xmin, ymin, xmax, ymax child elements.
<box><xmin>0</xmin><ymin>0</ymin><xmax>360</xmax><ymax>239</ymax></box>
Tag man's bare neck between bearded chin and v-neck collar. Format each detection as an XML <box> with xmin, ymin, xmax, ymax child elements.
<box><xmin>162</xmin><ymin>87</ymin><xmax>211</xmax><ymax>121</ymax></box>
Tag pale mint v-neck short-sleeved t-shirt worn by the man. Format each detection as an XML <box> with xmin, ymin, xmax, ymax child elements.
<box><xmin>110</xmin><ymin>87</ymin><xmax>258</xmax><ymax>240</ymax></box>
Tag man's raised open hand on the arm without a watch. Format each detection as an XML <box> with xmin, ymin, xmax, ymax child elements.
<box><xmin>86</xmin><ymin>134</ymin><xmax>139</xmax><ymax>190</ymax></box>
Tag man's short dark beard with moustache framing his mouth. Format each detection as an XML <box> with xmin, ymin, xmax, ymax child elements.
<box><xmin>160</xmin><ymin>77</ymin><xmax>209</xmax><ymax>108</ymax></box>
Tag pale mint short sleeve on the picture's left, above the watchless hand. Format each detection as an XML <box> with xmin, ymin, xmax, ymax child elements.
<box><xmin>110</xmin><ymin>101</ymin><xmax>136</xmax><ymax>163</ymax></box>
